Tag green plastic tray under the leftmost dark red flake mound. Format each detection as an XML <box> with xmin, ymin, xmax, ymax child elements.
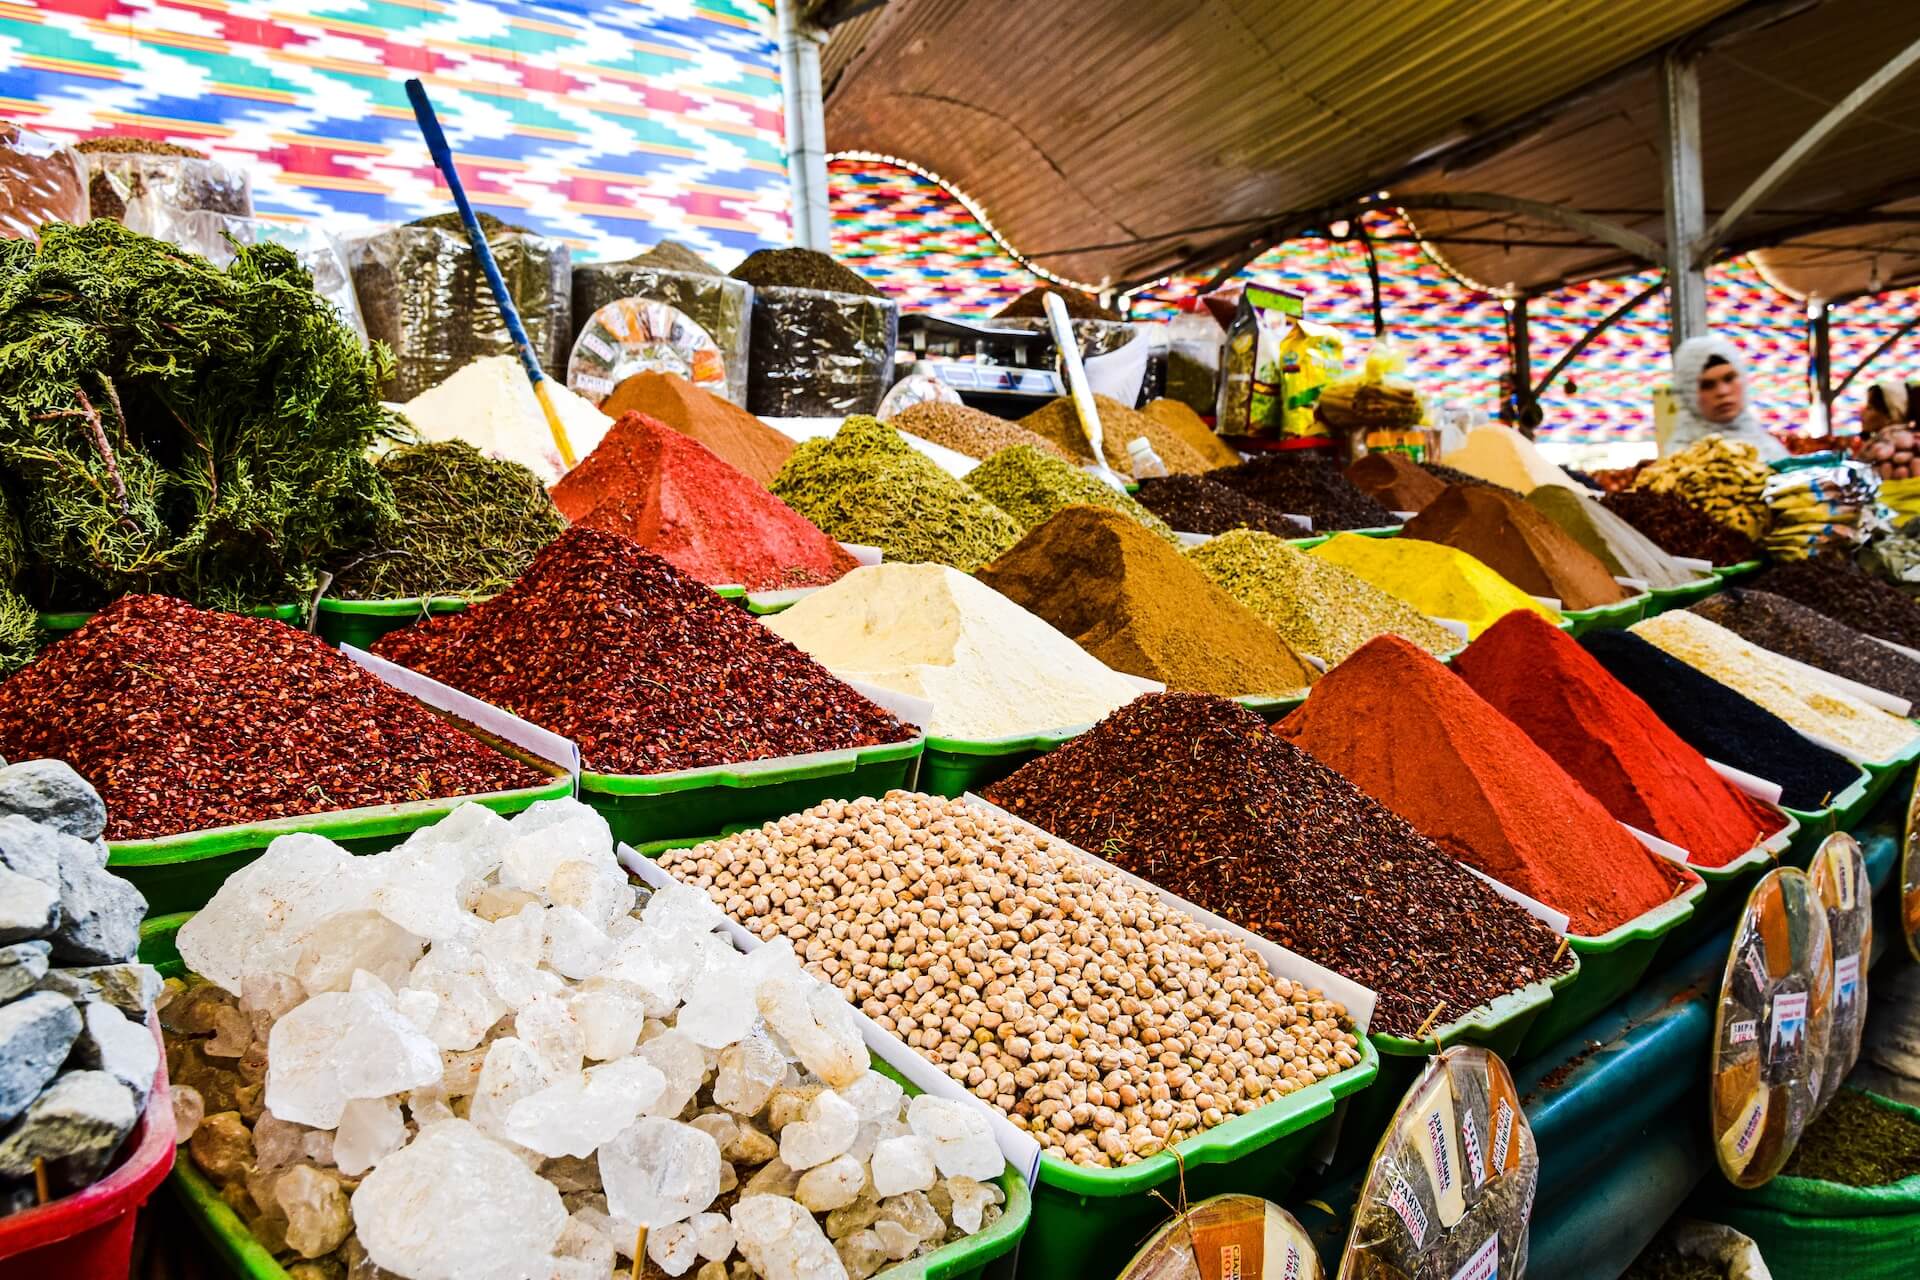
<box><xmin>108</xmin><ymin>775</ymin><xmax>574</xmax><ymax>913</ymax></box>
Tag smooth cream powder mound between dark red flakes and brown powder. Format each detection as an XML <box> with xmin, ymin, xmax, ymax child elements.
<box><xmin>766</xmin><ymin>564</ymin><xmax>1139</xmax><ymax>739</ymax></box>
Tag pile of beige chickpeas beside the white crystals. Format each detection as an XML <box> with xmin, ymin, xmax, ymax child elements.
<box><xmin>660</xmin><ymin>791</ymin><xmax>1361</xmax><ymax>1167</ymax></box>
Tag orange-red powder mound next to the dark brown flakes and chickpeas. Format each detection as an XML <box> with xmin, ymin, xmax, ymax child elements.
<box><xmin>1277</xmin><ymin>635</ymin><xmax>1699</xmax><ymax>936</ymax></box>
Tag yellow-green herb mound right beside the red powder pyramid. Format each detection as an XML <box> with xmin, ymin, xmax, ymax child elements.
<box><xmin>772</xmin><ymin>415</ymin><xmax>1021</xmax><ymax>572</ymax></box>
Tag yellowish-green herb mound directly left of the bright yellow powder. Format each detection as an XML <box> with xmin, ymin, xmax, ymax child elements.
<box><xmin>1187</xmin><ymin>530</ymin><xmax>1461</xmax><ymax>666</ymax></box>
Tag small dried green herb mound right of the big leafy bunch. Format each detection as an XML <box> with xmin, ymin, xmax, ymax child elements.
<box><xmin>330</xmin><ymin>441</ymin><xmax>566</xmax><ymax>601</ymax></box>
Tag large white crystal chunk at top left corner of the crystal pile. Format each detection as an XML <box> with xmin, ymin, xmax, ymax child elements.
<box><xmin>175</xmin><ymin>833</ymin><xmax>372</xmax><ymax>990</ymax></box>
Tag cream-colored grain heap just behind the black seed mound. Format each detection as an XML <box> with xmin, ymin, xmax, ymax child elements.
<box><xmin>1632</xmin><ymin>608</ymin><xmax>1920</xmax><ymax>760</ymax></box>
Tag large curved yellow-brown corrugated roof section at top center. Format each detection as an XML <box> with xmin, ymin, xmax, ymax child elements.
<box><xmin>822</xmin><ymin>0</ymin><xmax>1736</xmax><ymax>282</ymax></box>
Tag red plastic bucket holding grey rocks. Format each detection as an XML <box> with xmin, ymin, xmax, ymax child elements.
<box><xmin>0</xmin><ymin>1017</ymin><xmax>173</xmax><ymax>1280</ymax></box>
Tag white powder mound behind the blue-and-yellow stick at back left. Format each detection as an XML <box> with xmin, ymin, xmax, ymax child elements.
<box><xmin>399</xmin><ymin>355</ymin><xmax>612</xmax><ymax>489</ymax></box>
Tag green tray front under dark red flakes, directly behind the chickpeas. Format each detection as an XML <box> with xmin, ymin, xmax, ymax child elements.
<box><xmin>580</xmin><ymin>737</ymin><xmax>925</xmax><ymax>844</ymax></box>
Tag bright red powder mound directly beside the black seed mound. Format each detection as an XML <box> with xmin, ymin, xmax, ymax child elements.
<box><xmin>1453</xmin><ymin>612</ymin><xmax>1786</xmax><ymax>867</ymax></box>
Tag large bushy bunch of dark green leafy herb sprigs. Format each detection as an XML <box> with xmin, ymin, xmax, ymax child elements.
<box><xmin>0</xmin><ymin>219</ymin><xmax>396</xmax><ymax>606</ymax></box>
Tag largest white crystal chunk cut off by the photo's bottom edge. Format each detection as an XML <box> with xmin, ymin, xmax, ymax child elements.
<box><xmin>353</xmin><ymin>1121</ymin><xmax>566</xmax><ymax>1280</ymax></box>
